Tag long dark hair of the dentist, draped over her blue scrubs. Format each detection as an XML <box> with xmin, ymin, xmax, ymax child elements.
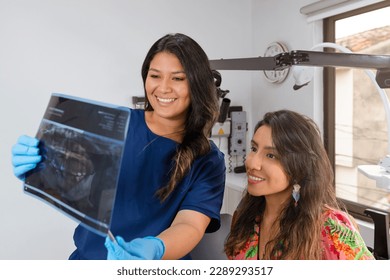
<box><xmin>142</xmin><ymin>33</ymin><xmax>219</xmax><ymax>200</ymax></box>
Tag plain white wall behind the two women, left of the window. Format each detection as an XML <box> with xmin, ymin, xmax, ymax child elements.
<box><xmin>0</xmin><ymin>0</ymin><xmax>328</xmax><ymax>259</ymax></box>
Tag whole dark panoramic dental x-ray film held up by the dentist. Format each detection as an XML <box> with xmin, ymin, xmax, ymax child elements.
<box><xmin>24</xmin><ymin>94</ymin><xmax>130</xmax><ymax>236</ymax></box>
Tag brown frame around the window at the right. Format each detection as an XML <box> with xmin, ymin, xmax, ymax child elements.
<box><xmin>323</xmin><ymin>1</ymin><xmax>390</xmax><ymax>222</ymax></box>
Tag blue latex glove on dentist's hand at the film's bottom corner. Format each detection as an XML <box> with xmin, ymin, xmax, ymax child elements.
<box><xmin>104</xmin><ymin>236</ymin><xmax>165</xmax><ymax>260</ymax></box>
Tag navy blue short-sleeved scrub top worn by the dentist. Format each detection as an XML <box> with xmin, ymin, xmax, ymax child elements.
<box><xmin>69</xmin><ymin>109</ymin><xmax>226</xmax><ymax>259</ymax></box>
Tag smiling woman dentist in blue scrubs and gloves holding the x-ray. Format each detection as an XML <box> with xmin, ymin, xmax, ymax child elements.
<box><xmin>12</xmin><ymin>33</ymin><xmax>226</xmax><ymax>260</ymax></box>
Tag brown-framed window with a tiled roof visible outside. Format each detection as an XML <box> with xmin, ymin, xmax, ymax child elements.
<box><xmin>324</xmin><ymin>1</ymin><xmax>390</xmax><ymax>219</ymax></box>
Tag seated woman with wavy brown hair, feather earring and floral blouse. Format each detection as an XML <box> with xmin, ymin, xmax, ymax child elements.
<box><xmin>225</xmin><ymin>110</ymin><xmax>373</xmax><ymax>260</ymax></box>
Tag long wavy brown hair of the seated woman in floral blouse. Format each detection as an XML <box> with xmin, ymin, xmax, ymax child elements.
<box><xmin>225</xmin><ymin>110</ymin><xmax>340</xmax><ymax>259</ymax></box>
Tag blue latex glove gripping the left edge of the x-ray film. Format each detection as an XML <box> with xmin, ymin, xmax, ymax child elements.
<box><xmin>12</xmin><ymin>135</ymin><xmax>42</xmax><ymax>180</ymax></box>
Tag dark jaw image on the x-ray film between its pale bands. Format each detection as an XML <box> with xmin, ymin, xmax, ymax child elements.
<box><xmin>26</xmin><ymin>123</ymin><xmax>121</xmax><ymax>230</ymax></box>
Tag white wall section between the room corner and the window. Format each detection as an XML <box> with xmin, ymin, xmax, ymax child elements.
<box><xmin>251</xmin><ymin>0</ymin><xmax>323</xmax><ymax>135</ymax></box>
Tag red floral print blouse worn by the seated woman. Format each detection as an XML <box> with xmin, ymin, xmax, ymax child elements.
<box><xmin>228</xmin><ymin>209</ymin><xmax>374</xmax><ymax>260</ymax></box>
